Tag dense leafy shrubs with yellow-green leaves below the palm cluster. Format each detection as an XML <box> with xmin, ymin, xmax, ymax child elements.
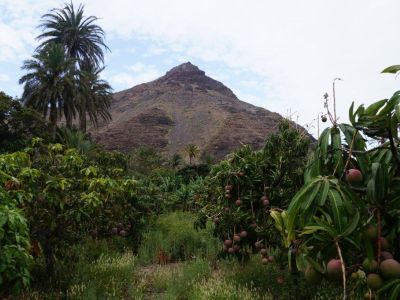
<box><xmin>0</xmin><ymin>139</ymin><xmax>163</xmax><ymax>290</ymax></box>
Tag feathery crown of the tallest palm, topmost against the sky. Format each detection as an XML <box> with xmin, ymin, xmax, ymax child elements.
<box><xmin>37</xmin><ymin>2</ymin><xmax>109</xmax><ymax>66</ymax></box>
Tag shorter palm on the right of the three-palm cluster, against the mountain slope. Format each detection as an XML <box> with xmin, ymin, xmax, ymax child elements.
<box><xmin>77</xmin><ymin>61</ymin><xmax>112</xmax><ymax>132</ymax></box>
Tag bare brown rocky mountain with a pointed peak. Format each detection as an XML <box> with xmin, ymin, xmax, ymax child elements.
<box><xmin>90</xmin><ymin>62</ymin><xmax>300</xmax><ymax>159</ymax></box>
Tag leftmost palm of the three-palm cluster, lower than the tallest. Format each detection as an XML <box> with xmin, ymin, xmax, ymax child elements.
<box><xmin>19</xmin><ymin>43</ymin><xmax>75</xmax><ymax>137</ymax></box>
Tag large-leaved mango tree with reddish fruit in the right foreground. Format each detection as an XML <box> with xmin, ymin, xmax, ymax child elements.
<box><xmin>274</xmin><ymin>67</ymin><xmax>400</xmax><ymax>299</ymax></box>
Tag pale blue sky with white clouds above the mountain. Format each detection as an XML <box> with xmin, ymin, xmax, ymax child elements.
<box><xmin>0</xmin><ymin>0</ymin><xmax>400</xmax><ymax>135</ymax></box>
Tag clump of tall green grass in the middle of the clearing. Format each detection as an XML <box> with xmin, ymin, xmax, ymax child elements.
<box><xmin>138</xmin><ymin>212</ymin><xmax>218</xmax><ymax>263</ymax></box>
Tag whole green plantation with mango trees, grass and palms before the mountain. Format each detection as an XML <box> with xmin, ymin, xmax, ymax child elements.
<box><xmin>0</xmin><ymin>2</ymin><xmax>400</xmax><ymax>300</ymax></box>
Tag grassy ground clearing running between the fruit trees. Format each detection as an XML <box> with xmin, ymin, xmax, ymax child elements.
<box><xmin>17</xmin><ymin>212</ymin><xmax>346</xmax><ymax>300</ymax></box>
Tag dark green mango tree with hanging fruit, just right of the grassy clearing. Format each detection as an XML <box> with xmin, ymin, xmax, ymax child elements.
<box><xmin>196</xmin><ymin>121</ymin><xmax>310</xmax><ymax>260</ymax></box>
